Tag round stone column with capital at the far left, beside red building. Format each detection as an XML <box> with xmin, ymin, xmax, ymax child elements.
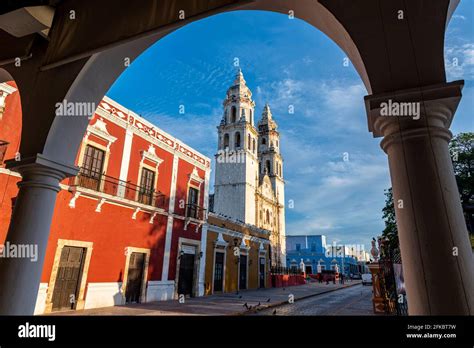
<box><xmin>0</xmin><ymin>154</ymin><xmax>77</xmax><ymax>315</ymax></box>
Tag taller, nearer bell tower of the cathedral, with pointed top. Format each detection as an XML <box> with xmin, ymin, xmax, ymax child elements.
<box><xmin>214</xmin><ymin>69</ymin><xmax>258</xmax><ymax>224</ymax></box>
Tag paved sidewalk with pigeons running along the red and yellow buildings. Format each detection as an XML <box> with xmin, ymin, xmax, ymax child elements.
<box><xmin>50</xmin><ymin>280</ymin><xmax>361</xmax><ymax>315</ymax></box>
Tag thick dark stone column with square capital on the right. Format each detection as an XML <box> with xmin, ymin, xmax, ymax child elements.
<box><xmin>365</xmin><ymin>81</ymin><xmax>474</xmax><ymax>315</ymax></box>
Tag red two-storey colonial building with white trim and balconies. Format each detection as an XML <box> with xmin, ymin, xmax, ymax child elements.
<box><xmin>0</xmin><ymin>83</ymin><xmax>210</xmax><ymax>314</ymax></box>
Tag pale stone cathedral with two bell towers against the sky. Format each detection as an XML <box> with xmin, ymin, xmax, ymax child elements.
<box><xmin>213</xmin><ymin>70</ymin><xmax>286</xmax><ymax>266</ymax></box>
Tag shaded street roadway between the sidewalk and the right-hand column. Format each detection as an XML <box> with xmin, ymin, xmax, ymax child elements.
<box><xmin>255</xmin><ymin>285</ymin><xmax>374</xmax><ymax>316</ymax></box>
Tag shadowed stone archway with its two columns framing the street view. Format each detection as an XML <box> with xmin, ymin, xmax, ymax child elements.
<box><xmin>0</xmin><ymin>0</ymin><xmax>474</xmax><ymax>314</ymax></box>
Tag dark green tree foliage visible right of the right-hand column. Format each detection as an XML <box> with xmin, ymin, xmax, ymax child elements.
<box><xmin>449</xmin><ymin>132</ymin><xmax>474</xmax><ymax>234</ymax></box>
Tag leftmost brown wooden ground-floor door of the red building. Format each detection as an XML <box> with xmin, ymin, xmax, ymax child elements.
<box><xmin>52</xmin><ymin>246</ymin><xmax>86</xmax><ymax>311</ymax></box>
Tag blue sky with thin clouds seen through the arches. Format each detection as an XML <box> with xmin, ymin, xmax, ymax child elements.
<box><xmin>107</xmin><ymin>1</ymin><xmax>474</xmax><ymax>248</ymax></box>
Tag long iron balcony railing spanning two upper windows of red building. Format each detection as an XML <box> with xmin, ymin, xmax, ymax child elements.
<box><xmin>69</xmin><ymin>167</ymin><xmax>167</xmax><ymax>209</ymax></box>
